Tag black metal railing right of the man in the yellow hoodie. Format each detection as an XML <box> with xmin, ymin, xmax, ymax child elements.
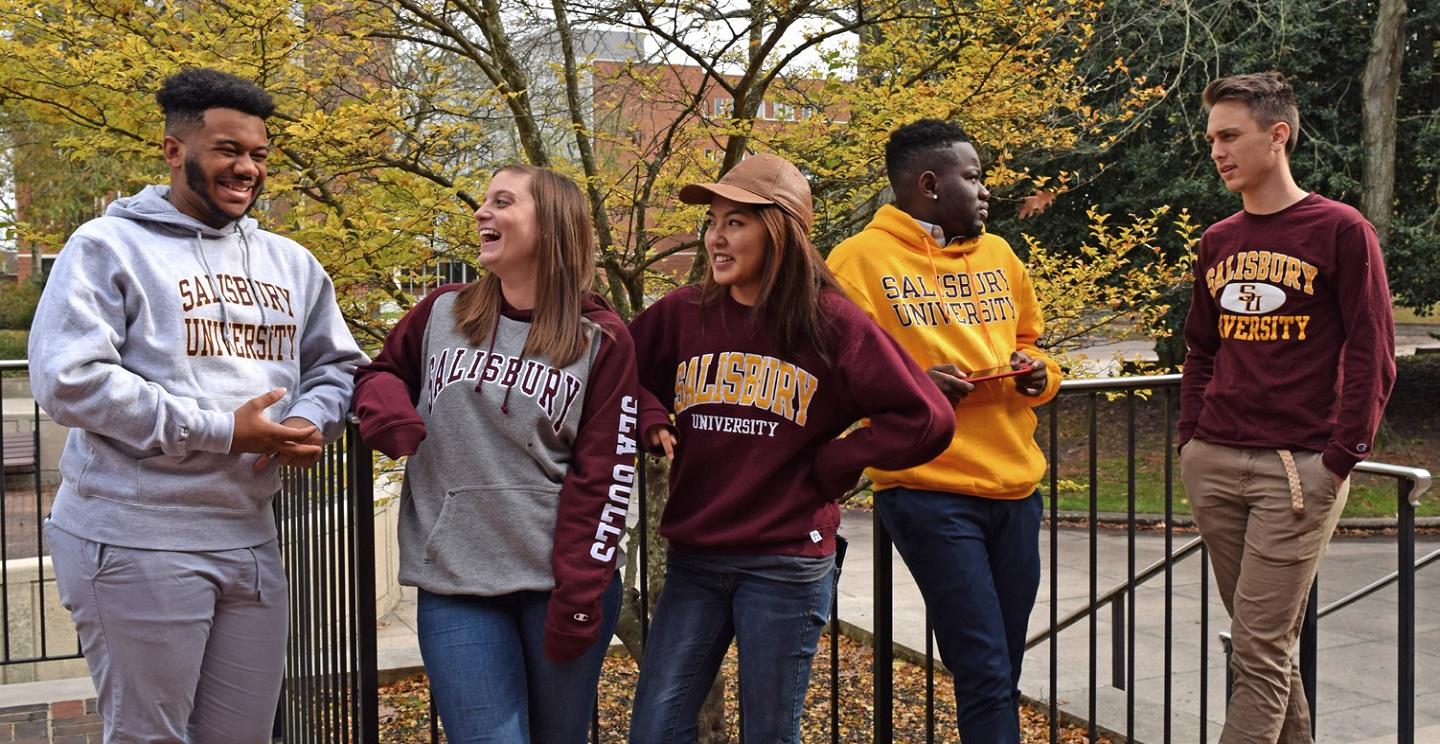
<box><xmin>1027</xmin><ymin>374</ymin><xmax>1440</xmax><ymax>743</ymax></box>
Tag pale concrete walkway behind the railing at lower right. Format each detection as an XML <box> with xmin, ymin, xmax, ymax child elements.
<box><xmin>840</xmin><ymin>512</ymin><xmax>1440</xmax><ymax>744</ymax></box>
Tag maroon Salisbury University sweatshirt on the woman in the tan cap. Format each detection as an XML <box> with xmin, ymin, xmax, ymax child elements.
<box><xmin>629</xmin><ymin>286</ymin><xmax>955</xmax><ymax>555</ymax></box>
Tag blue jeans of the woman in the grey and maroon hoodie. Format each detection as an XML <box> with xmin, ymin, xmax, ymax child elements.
<box><xmin>418</xmin><ymin>576</ymin><xmax>621</xmax><ymax>744</ymax></box>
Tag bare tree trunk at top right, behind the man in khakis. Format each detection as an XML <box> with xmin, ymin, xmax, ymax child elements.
<box><xmin>1359</xmin><ymin>0</ymin><xmax>1405</xmax><ymax>245</ymax></box>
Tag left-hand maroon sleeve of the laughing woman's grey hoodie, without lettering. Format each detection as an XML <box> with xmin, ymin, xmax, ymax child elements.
<box><xmin>351</xmin><ymin>285</ymin><xmax>464</xmax><ymax>458</ymax></box>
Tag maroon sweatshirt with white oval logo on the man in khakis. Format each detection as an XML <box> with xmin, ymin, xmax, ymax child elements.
<box><xmin>1179</xmin><ymin>194</ymin><xmax>1395</xmax><ymax>476</ymax></box>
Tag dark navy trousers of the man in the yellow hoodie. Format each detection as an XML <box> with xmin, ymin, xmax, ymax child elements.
<box><xmin>876</xmin><ymin>488</ymin><xmax>1044</xmax><ymax>744</ymax></box>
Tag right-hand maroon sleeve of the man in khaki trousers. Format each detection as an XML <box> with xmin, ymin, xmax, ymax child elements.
<box><xmin>1320</xmin><ymin>222</ymin><xmax>1395</xmax><ymax>478</ymax></box>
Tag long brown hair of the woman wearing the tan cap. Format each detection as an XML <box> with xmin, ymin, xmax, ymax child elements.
<box><xmin>700</xmin><ymin>204</ymin><xmax>840</xmax><ymax>364</ymax></box>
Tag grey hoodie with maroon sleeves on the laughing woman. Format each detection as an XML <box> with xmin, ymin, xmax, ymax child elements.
<box><xmin>354</xmin><ymin>285</ymin><xmax>639</xmax><ymax>661</ymax></box>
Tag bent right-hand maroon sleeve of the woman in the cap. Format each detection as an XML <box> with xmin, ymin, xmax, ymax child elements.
<box><xmin>814</xmin><ymin>302</ymin><xmax>955</xmax><ymax>498</ymax></box>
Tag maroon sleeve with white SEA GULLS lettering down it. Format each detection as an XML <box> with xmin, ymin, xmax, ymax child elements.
<box><xmin>544</xmin><ymin>311</ymin><xmax>639</xmax><ymax>662</ymax></box>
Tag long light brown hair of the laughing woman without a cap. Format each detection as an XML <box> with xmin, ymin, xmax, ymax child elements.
<box><xmin>455</xmin><ymin>165</ymin><xmax>595</xmax><ymax>367</ymax></box>
